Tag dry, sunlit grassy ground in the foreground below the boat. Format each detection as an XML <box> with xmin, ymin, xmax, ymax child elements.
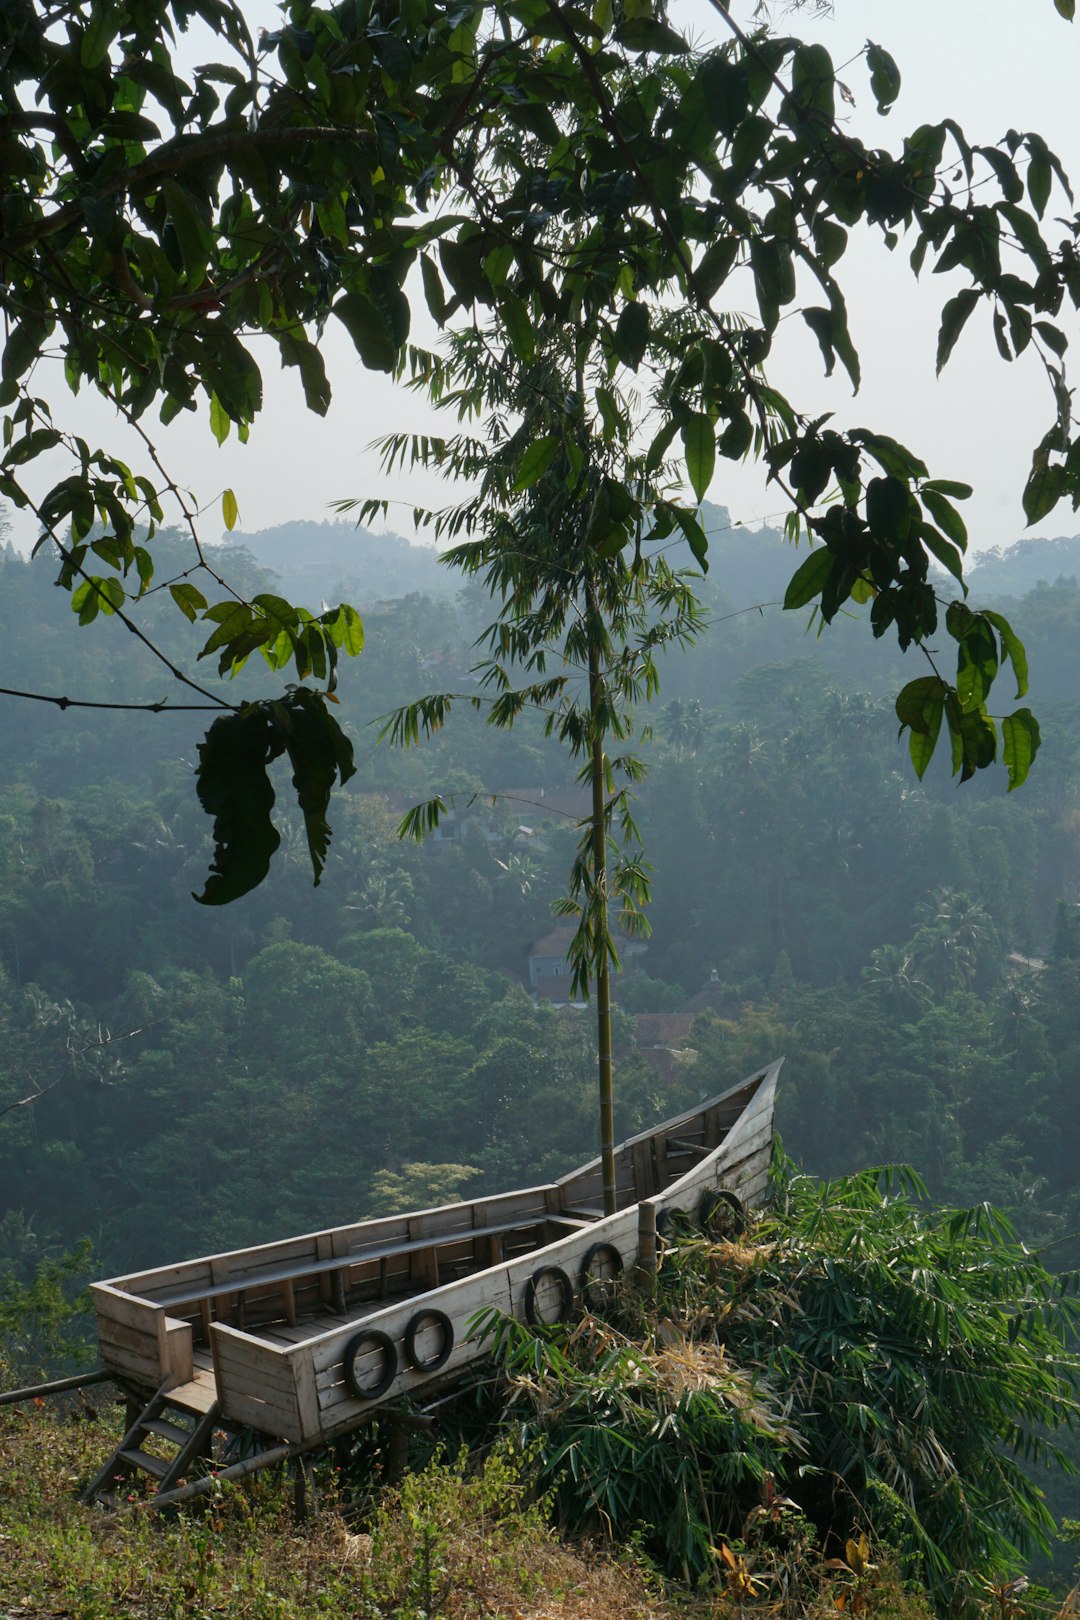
<box><xmin>0</xmin><ymin>1406</ymin><xmax>687</xmax><ymax>1620</ymax></box>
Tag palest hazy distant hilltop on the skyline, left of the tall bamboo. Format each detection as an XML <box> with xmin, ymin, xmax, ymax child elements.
<box><xmin>227</xmin><ymin>518</ymin><xmax>460</xmax><ymax>608</ymax></box>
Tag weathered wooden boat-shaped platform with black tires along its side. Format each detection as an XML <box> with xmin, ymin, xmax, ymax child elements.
<box><xmin>84</xmin><ymin>1063</ymin><xmax>780</xmax><ymax>1458</ymax></box>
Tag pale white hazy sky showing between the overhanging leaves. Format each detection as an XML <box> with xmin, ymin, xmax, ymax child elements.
<box><xmin>15</xmin><ymin>0</ymin><xmax>1080</xmax><ymax>548</ymax></box>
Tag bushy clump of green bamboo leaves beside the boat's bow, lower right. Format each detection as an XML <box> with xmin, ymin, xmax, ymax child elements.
<box><xmin>476</xmin><ymin>1170</ymin><xmax>1080</xmax><ymax>1609</ymax></box>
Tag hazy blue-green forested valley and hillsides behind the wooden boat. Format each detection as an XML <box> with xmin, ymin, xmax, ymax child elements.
<box><xmin>0</xmin><ymin>509</ymin><xmax>1080</xmax><ymax>1275</ymax></box>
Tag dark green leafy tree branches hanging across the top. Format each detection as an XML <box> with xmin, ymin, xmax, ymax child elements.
<box><xmin>0</xmin><ymin>0</ymin><xmax>1080</xmax><ymax>901</ymax></box>
